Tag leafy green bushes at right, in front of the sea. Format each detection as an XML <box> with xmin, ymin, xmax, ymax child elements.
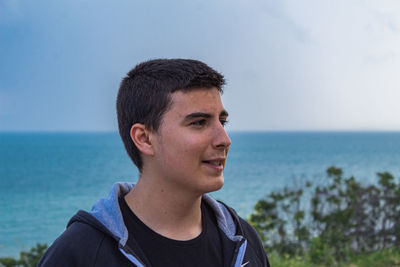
<box><xmin>249</xmin><ymin>167</ymin><xmax>400</xmax><ymax>267</ymax></box>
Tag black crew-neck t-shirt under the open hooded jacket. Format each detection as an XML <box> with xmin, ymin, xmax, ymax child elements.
<box><xmin>119</xmin><ymin>198</ymin><xmax>224</xmax><ymax>267</ymax></box>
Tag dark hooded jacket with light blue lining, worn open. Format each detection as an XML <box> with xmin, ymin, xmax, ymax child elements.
<box><xmin>38</xmin><ymin>183</ymin><xmax>270</xmax><ymax>267</ymax></box>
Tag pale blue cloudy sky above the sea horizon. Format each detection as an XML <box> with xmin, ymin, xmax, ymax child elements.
<box><xmin>0</xmin><ymin>0</ymin><xmax>400</xmax><ymax>131</ymax></box>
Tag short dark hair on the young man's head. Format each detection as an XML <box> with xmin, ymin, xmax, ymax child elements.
<box><xmin>117</xmin><ymin>59</ymin><xmax>225</xmax><ymax>172</ymax></box>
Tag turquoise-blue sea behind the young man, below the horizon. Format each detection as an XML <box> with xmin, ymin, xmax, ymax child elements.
<box><xmin>0</xmin><ymin>132</ymin><xmax>400</xmax><ymax>257</ymax></box>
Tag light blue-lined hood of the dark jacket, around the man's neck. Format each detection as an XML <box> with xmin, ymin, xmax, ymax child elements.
<box><xmin>67</xmin><ymin>183</ymin><xmax>256</xmax><ymax>267</ymax></box>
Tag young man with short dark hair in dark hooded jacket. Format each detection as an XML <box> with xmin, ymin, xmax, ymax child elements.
<box><xmin>39</xmin><ymin>59</ymin><xmax>269</xmax><ymax>267</ymax></box>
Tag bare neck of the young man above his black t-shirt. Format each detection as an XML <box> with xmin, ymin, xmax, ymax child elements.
<box><xmin>125</xmin><ymin>174</ymin><xmax>202</xmax><ymax>243</ymax></box>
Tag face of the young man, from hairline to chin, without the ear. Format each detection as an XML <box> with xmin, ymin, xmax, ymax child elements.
<box><xmin>152</xmin><ymin>88</ymin><xmax>231</xmax><ymax>194</ymax></box>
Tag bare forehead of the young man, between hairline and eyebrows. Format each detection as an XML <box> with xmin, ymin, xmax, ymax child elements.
<box><xmin>167</xmin><ymin>88</ymin><xmax>224</xmax><ymax>116</ymax></box>
